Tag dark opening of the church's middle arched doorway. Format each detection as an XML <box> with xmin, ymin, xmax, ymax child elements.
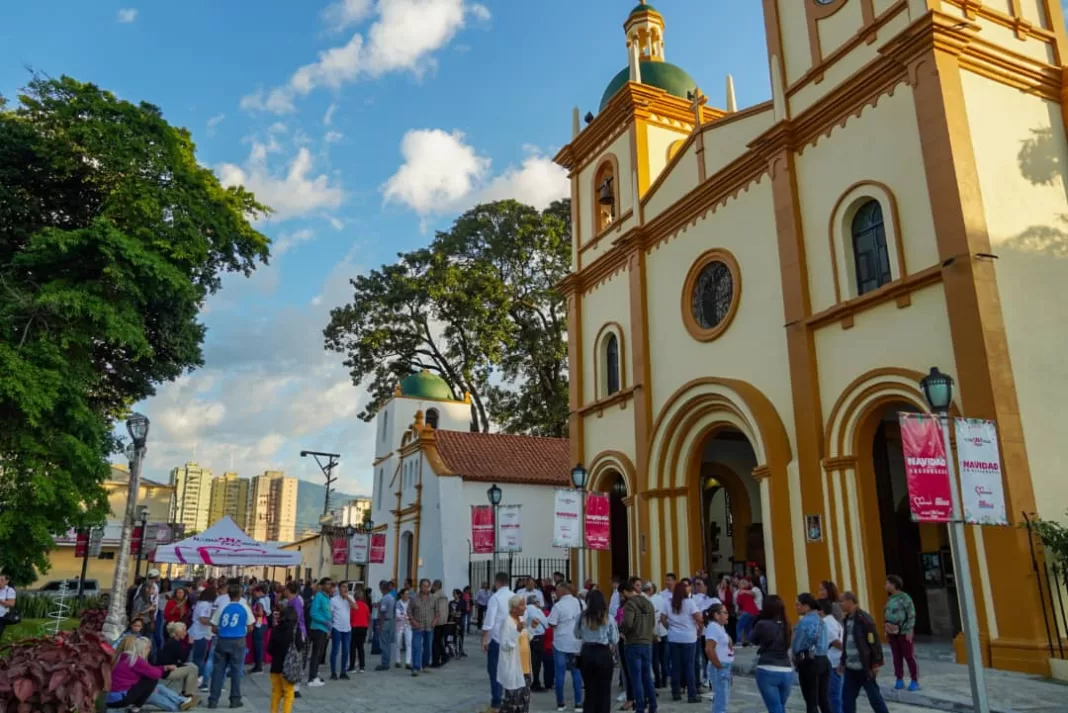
<box><xmin>690</xmin><ymin>427</ymin><xmax>767</xmax><ymax>579</ymax></box>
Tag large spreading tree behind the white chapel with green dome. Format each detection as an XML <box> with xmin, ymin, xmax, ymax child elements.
<box><xmin>325</xmin><ymin>201</ymin><xmax>571</xmax><ymax>435</ymax></box>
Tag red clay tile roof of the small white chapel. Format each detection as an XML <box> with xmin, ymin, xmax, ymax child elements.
<box><xmin>435</xmin><ymin>430</ymin><xmax>571</xmax><ymax>487</ymax></box>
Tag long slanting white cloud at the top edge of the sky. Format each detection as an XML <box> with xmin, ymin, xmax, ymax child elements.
<box><xmin>241</xmin><ymin>0</ymin><xmax>489</xmax><ymax>114</ymax></box>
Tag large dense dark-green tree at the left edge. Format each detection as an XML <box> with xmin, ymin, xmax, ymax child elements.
<box><xmin>0</xmin><ymin>77</ymin><xmax>268</xmax><ymax>582</ymax></box>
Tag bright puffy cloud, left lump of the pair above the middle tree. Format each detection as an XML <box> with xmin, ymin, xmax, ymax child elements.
<box><xmin>382</xmin><ymin>129</ymin><xmax>490</xmax><ymax>216</ymax></box>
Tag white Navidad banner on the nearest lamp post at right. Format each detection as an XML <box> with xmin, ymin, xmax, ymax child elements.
<box><xmin>956</xmin><ymin>418</ymin><xmax>1008</xmax><ymax>525</ymax></box>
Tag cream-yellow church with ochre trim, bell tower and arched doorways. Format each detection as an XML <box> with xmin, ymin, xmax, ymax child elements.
<box><xmin>556</xmin><ymin>0</ymin><xmax>1068</xmax><ymax>674</ymax></box>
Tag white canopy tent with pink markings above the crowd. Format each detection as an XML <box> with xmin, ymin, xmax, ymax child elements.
<box><xmin>153</xmin><ymin>517</ymin><xmax>301</xmax><ymax>567</ymax></box>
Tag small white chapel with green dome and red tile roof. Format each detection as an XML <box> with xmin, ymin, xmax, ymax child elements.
<box><xmin>366</xmin><ymin>371</ymin><xmax>571</xmax><ymax>591</ymax></box>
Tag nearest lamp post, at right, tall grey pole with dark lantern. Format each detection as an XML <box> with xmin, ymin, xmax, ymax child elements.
<box><xmin>920</xmin><ymin>366</ymin><xmax>990</xmax><ymax>713</ymax></box>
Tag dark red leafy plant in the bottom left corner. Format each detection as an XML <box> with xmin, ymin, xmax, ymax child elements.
<box><xmin>0</xmin><ymin>630</ymin><xmax>114</xmax><ymax>713</ymax></box>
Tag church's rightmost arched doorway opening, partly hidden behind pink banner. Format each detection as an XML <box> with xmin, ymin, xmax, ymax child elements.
<box><xmin>858</xmin><ymin>401</ymin><xmax>960</xmax><ymax>638</ymax></box>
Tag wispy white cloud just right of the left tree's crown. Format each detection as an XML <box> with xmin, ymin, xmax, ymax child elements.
<box><xmin>216</xmin><ymin>138</ymin><xmax>344</xmax><ymax>221</ymax></box>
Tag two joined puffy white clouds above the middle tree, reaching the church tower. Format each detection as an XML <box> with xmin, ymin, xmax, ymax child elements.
<box><xmin>382</xmin><ymin>129</ymin><xmax>570</xmax><ymax>217</ymax></box>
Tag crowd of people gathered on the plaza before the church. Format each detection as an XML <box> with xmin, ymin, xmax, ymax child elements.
<box><xmin>93</xmin><ymin>569</ymin><xmax>918</xmax><ymax>713</ymax></box>
